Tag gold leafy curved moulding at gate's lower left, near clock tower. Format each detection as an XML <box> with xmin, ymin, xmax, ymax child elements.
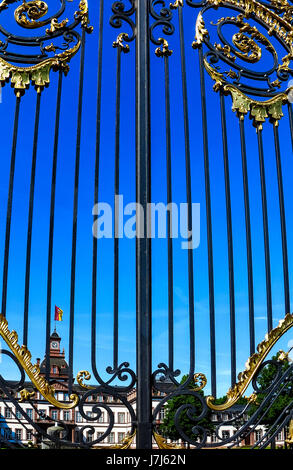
<box><xmin>0</xmin><ymin>314</ymin><xmax>79</xmax><ymax>410</ymax></box>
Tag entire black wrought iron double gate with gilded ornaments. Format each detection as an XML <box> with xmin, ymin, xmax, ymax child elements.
<box><xmin>0</xmin><ymin>0</ymin><xmax>293</xmax><ymax>449</ymax></box>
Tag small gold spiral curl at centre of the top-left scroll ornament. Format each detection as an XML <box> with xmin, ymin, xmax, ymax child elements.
<box><xmin>14</xmin><ymin>0</ymin><xmax>48</xmax><ymax>28</ymax></box>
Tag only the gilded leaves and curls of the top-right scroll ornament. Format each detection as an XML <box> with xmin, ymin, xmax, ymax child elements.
<box><xmin>192</xmin><ymin>0</ymin><xmax>293</xmax><ymax>129</ymax></box>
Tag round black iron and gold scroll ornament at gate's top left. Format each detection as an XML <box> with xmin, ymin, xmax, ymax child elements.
<box><xmin>0</xmin><ymin>0</ymin><xmax>93</xmax><ymax>97</ymax></box>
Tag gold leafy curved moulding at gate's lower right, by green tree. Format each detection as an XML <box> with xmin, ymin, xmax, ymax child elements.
<box><xmin>206</xmin><ymin>313</ymin><xmax>293</xmax><ymax>411</ymax></box>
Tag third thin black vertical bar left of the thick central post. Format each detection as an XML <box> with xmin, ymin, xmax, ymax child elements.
<box><xmin>68</xmin><ymin>28</ymin><xmax>86</xmax><ymax>393</ymax></box>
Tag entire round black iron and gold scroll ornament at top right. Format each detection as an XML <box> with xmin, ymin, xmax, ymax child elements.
<box><xmin>192</xmin><ymin>0</ymin><xmax>293</xmax><ymax>129</ymax></box>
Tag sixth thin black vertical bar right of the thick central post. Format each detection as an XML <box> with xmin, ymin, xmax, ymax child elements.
<box><xmin>257</xmin><ymin>127</ymin><xmax>273</xmax><ymax>331</ymax></box>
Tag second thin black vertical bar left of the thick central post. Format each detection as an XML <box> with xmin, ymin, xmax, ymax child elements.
<box><xmin>91</xmin><ymin>0</ymin><xmax>104</xmax><ymax>380</ymax></box>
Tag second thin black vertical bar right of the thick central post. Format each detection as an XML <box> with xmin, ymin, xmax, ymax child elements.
<box><xmin>178</xmin><ymin>6</ymin><xmax>195</xmax><ymax>388</ymax></box>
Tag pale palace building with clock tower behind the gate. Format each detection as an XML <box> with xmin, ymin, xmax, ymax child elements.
<box><xmin>0</xmin><ymin>330</ymin><xmax>284</xmax><ymax>448</ymax></box>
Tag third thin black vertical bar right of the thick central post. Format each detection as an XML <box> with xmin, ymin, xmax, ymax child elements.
<box><xmin>198</xmin><ymin>47</ymin><xmax>217</xmax><ymax>397</ymax></box>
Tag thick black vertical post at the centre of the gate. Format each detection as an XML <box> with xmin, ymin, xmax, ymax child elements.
<box><xmin>135</xmin><ymin>0</ymin><xmax>152</xmax><ymax>449</ymax></box>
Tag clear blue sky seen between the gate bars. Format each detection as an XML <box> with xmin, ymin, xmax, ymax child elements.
<box><xmin>0</xmin><ymin>0</ymin><xmax>293</xmax><ymax>395</ymax></box>
